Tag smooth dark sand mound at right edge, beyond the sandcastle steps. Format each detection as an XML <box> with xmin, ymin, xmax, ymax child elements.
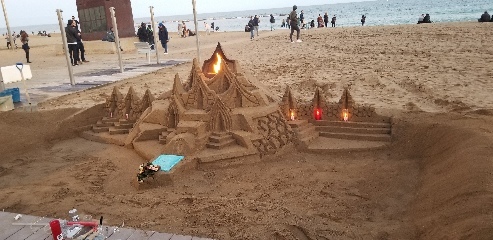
<box><xmin>397</xmin><ymin>111</ymin><xmax>493</xmax><ymax>239</ymax></box>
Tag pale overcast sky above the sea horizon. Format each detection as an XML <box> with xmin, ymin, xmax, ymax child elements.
<box><xmin>0</xmin><ymin>0</ymin><xmax>368</xmax><ymax>28</ymax></box>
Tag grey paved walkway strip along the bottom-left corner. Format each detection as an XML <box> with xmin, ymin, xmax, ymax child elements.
<box><xmin>0</xmin><ymin>212</ymin><xmax>212</xmax><ymax>240</ymax></box>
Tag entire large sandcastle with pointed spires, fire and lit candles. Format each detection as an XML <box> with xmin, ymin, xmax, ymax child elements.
<box><xmin>82</xmin><ymin>44</ymin><xmax>390</xmax><ymax>171</ymax></box>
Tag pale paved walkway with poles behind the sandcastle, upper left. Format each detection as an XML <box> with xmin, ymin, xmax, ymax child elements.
<box><xmin>0</xmin><ymin>55</ymin><xmax>191</xmax><ymax>108</ymax></box>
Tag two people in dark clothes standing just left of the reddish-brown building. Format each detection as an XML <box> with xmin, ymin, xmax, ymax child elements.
<box><xmin>65</xmin><ymin>16</ymin><xmax>89</xmax><ymax>66</ymax></box>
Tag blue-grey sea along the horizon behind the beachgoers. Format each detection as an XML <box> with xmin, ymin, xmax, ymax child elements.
<box><xmin>0</xmin><ymin>0</ymin><xmax>493</xmax><ymax>34</ymax></box>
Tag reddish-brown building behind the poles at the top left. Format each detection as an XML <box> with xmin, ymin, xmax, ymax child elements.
<box><xmin>76</xmin><ymin>0</ymin><xmax>135</xmax><ymax>40</ymax></box>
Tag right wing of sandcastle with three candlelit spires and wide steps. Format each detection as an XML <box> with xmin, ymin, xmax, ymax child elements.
<box><xmin>280</xmin><ymin>87</ymin><xmax>392</xmax><ymax>153</ymax></box>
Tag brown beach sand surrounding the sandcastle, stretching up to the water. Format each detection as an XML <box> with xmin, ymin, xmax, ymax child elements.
<box><xmin>0</xmin><ymin>23</ymin><xmax>493</xmax><ymax>240</ymax></box>
